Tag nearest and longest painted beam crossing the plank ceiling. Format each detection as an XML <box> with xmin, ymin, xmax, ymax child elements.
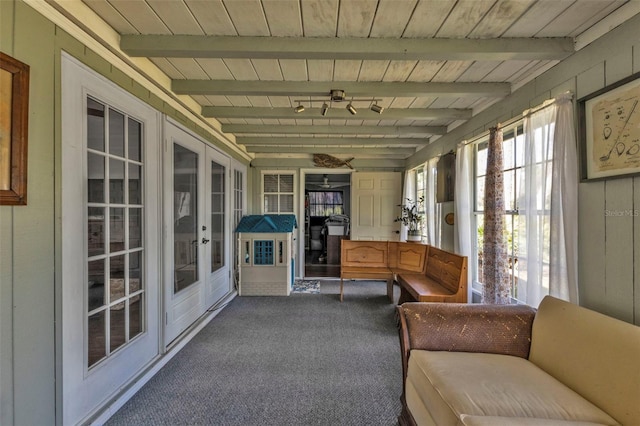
<box><xmin>120</xmin><ymin>35</ymin><xmax>575</xmax><ymax>61</ymax></box>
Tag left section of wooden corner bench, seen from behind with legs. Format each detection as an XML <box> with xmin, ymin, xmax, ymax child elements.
<box><xmin>340</xmin><ymin>240</ymin><xmax>428</xmax><ymax>302</ymax></box>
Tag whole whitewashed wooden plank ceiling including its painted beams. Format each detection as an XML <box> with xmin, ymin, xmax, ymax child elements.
<box><xmin>76</xmin><ymin>0</ymin><xmax>627</xmax><ymax>159</ymax></box>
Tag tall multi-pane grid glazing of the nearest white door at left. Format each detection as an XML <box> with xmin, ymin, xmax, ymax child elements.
<box><xmin>86</xmin><ymin>98</ymin><xmax>145</xmax><ymax>367</ymax></box>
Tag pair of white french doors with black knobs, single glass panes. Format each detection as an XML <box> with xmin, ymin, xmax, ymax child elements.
<box><xmin>164</xmin><ymin>120</ymin><xmax>232</xmax><ymax>345</ymax></box>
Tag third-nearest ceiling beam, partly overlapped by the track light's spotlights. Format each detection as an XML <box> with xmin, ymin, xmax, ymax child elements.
<box><xmin>202</xmin><ymin>103</ymin><xmax>473</xmax><ymax>120</ymax></box>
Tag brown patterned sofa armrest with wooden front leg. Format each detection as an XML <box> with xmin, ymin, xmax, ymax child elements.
<box><xmin>397</xmin><ymin>302</ymin><xmax>536</xmax><ymax>388</ymax></box>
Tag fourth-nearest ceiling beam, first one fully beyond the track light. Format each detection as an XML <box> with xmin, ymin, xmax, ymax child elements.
<box><xmin>222</xmin><ymin>124</ymin><xmax>447</xmax><ymax>137</ymax></box>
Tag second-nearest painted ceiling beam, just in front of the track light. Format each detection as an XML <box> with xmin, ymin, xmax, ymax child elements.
<box><xmin>171</xmin><ymin>80</ymin><xmax>511</xmax><ymax>100</ymax></box>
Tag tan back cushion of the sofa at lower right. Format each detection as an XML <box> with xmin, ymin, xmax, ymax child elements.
<box><xmin>529</xmin><ymin>296</ymin><xmax>640</xmax><ymax>424</ymax></box>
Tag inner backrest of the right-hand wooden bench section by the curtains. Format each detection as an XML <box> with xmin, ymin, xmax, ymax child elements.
<box><xmin>425</xmin><ymin>246</ymin><xmax>467</xmax><ymax>302</ymax></box>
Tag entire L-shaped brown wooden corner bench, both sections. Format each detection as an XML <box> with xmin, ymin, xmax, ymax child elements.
<box><xmin>340</xmin><ymin>240</ymin><xmax>467</xmax><ymax>304</ymax></box>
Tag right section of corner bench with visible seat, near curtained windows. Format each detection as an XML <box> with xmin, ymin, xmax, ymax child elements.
<box><xmin>396</xmin><ymin>246</ymin><xmax>467</xmax><ymax>305</ymax></box>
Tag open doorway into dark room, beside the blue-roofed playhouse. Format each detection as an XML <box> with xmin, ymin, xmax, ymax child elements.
<box><xmin>304</xmin><ymin>172</ymin><xmax>351</xmax><ymax>277</ymax></box>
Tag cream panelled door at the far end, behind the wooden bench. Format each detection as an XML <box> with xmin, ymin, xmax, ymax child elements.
<box><xmin>351</xmin><ymin>172</ymin><xmax>402</xmax><ymax>241</ymax></box>
